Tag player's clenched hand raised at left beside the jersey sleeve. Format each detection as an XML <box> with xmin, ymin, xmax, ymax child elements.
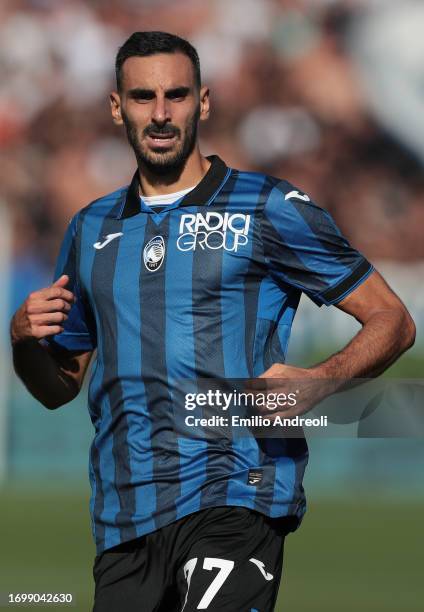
<box><xmin>10</xmin><ymin>274</ymin><xmax>76</xmax><ymax>344</ymax></box>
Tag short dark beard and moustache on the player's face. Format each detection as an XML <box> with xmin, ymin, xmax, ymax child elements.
<box><xmin>122</xmin><ymin>106</ymin><xmax>200</xmax><ymax>176</ymax></box>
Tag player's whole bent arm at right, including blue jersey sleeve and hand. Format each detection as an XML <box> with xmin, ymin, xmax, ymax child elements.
<box><xmin>260</xmin><ymin>181</ymin><xmax>415</xmax><ymax>416</ymax></box>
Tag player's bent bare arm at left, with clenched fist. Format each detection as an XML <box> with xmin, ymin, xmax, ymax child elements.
<box><xmin>10</xmin><ymin>275</ymin><xmax>92</xmax><ymax>409</ymax></box>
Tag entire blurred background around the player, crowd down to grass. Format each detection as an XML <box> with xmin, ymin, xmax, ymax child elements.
<box><xmin>0</xmin><ymin>0</ymin><xmax>424</xmax><ymax>612</ymax></box>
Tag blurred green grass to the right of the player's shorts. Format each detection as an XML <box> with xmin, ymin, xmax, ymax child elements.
<box><xmin>276</xmin><ymin>499</ymin><xmax>424</xmax><ymax>612</ymax></box>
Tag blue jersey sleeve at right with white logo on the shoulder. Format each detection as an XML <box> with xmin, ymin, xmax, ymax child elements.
<box><xmin>262</xmin><ymin>181</ymin><xmax>374</xmax><ymax>306</ymax></box>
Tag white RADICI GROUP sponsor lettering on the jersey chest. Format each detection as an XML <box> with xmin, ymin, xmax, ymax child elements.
<box><xmin>177</xmin><ymin>212</ymin><xmax>250</xmax><ymax>251</ymax></box>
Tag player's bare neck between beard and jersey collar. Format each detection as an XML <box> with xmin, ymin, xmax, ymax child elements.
<box><xmin>138</xmin><ymin>146</ymin><xmax>211</xmax><ymax>196</ymax></box>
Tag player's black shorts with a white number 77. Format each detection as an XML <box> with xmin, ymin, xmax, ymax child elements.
<box><xmin>93</xmin><ymin>507</ymin><xmax>293</xmax><ymax>612</ymax></box>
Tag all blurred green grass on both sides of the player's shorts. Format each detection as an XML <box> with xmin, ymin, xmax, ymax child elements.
<box><xmin>0</xmin><ymin>489</ymin><xmax>424</xmax><ymax>612</ymax></box>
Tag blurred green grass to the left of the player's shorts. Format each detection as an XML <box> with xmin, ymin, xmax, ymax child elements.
<box><xmin>0</xmin><ymin>485</ymin><xmax>95</xmax><ymax>612</ymax></box>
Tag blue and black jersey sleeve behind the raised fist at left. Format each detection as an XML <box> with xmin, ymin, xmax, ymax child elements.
<box><xmin>45</xmin><ymin>215</ymin><xmax>97</xmax><ymax>351</ymax></box>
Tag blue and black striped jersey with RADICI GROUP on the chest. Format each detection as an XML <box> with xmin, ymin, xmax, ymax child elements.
<box><xmin>50</xmin><ymin>156</ymin><xmax>372</xmax><ymax>553</ymax></box>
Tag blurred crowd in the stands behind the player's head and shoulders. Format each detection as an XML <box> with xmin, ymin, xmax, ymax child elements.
<box><xmin>0</xmin><ymin>0</ymin><xmax>424</xmax><ymax>310</ymax></box>
